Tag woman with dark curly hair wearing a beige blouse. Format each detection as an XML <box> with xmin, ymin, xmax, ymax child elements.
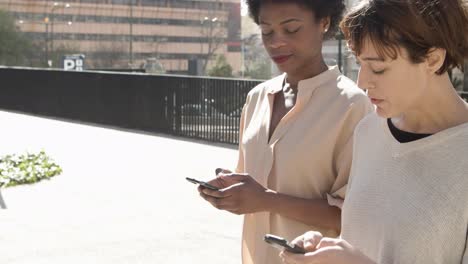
<box><xmin>199</xmin><ymin>0</ymin><xmax>374</xmax><ymax>264</ymax></box>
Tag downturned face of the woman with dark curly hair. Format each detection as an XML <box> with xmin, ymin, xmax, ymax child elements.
<box><xmin>258</xmin><ymin>3</ymin><xmax>329</xmax><ymax>79</ymax></box>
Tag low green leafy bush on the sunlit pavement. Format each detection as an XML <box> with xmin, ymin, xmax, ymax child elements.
<box><xmin>0</xmin><ymin>151</ymin><xmax>62</xmax><ymax>187</ymax></box>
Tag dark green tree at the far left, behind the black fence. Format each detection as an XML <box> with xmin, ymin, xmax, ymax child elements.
<box><xmin>0</xmin><ymin>10</ymin><xmax>33</xmax><ymax>66</ymax></box>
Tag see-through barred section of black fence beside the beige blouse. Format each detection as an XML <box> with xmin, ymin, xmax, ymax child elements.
<box><xmin>167</xmin><ymin>78</ymin><xmax>259</xmax><ymax>144</ymax></box>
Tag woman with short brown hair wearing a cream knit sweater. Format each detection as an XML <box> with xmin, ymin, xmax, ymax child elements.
<box><xmin>282</xmin><ymin>0</ymin><xmax>468</xmax><ymax>264</ymax></box>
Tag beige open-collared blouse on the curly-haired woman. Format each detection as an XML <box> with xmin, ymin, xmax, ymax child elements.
<box><xmin>236</xmin><ymin>67</ymin><xmax>374</xmax><ymax>264</ymax></box>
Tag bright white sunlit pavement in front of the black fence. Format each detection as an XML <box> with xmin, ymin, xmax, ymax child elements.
<box><xmin>0</xmin><ymin>112</ymin><xmax>242</xmax><ymax>264</ymax></box>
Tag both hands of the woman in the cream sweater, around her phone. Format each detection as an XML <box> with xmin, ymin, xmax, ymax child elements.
<box><xmin>280</xmin><ymin>231</ymin><xmax>375</xmax><ymax>264</ymax></box>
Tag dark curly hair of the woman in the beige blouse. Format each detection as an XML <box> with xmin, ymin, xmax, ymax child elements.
<box><xmin>245</xmin><ymin>0</ymin><xmax>345</xmax><ymax>39</ymax></box>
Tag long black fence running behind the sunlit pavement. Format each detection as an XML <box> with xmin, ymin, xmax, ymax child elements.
<box><xmin>0</xmin><ymin>68</ymin><xmax>259</xmax><ymax>144</ymax></box>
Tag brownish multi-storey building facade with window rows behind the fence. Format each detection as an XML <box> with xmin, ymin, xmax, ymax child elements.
<box><xmin>0</xmin><ymin>0</ymin><xmax>241</xmax><ymax>75</ymax></box>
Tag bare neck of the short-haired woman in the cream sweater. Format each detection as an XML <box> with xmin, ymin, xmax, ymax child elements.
<box><xmin>392</xmin><ymin>74</ymin><xmax>468</xmax><ymax>134</ymax></box>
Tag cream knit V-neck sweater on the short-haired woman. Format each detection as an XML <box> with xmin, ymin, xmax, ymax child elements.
<box><xmin>342</xmin><ymin>113</ymin><xmax>468</xmax><ymax>264</ymax></box>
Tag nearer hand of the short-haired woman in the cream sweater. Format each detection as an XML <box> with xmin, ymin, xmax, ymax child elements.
<box><xmin>280</xmin><ymin>237</ymin><xmax>375</xmax><ymax>264</ymax></box>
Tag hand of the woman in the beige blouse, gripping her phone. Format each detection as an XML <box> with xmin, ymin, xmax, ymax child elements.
<box><xmin>200</xmin><ymin>173</ymin><xmax>269</xmax><ymax>215</ymax></box>
